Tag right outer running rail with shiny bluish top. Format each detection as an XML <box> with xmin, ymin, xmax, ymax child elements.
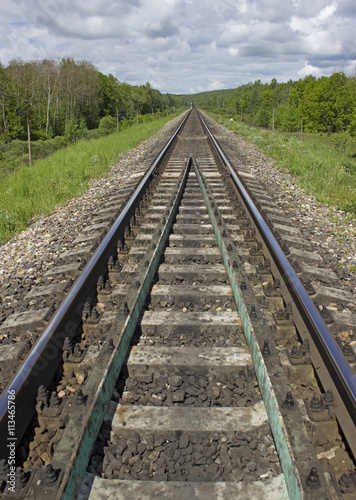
<box><xmin>199</xmin><ymin>109</ymin><xmax>356</xmax><ymax>425</ymax></box>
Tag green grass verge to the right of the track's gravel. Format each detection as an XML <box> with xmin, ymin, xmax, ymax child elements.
<box><xmin>208</xmin><ymin>113</ymin><xmax>356</xmax><ymax>216</ymax></box>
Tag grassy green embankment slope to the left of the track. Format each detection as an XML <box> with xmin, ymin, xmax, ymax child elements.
<box><xmin>0</xmin><ymin>113</ymin><xmax>178</xmax><ymax>244</ymax></box>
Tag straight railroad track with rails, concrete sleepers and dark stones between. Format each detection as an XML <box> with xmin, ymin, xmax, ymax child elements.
<box><xmin>0</xmin><ymin>110</ymin><xmax>356</xmax><ymax>499</ymax></box>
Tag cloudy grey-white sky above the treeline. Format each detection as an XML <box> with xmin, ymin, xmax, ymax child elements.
<box><xmin>0</xmin><ymin>0</ymin><xmax>356</xmax><ymax>94</ymax></box>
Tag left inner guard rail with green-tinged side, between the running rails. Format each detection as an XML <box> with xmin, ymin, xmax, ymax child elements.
<box><xmin>57</xmin><ymin>159</ymin><xmax>191</xmax><ymax>500</ymax></box>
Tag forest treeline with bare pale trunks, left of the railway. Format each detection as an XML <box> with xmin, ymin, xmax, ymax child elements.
<box><xmin>0</xmin><ymin>58</ymin><xmax>178</xmax><ymax>143</ymax></box>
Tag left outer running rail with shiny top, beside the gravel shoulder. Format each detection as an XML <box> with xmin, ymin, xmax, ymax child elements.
<box><xmin>0</xmin><ymin>111</ymin><xmax>190</xmax><ymax>459</ymax></box>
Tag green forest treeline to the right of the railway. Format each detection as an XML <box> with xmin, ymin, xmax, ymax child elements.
<box><xmin>179</xmin><ymin>72</ymin><xmax>356</xmax><ymax>137</ymax></box>
